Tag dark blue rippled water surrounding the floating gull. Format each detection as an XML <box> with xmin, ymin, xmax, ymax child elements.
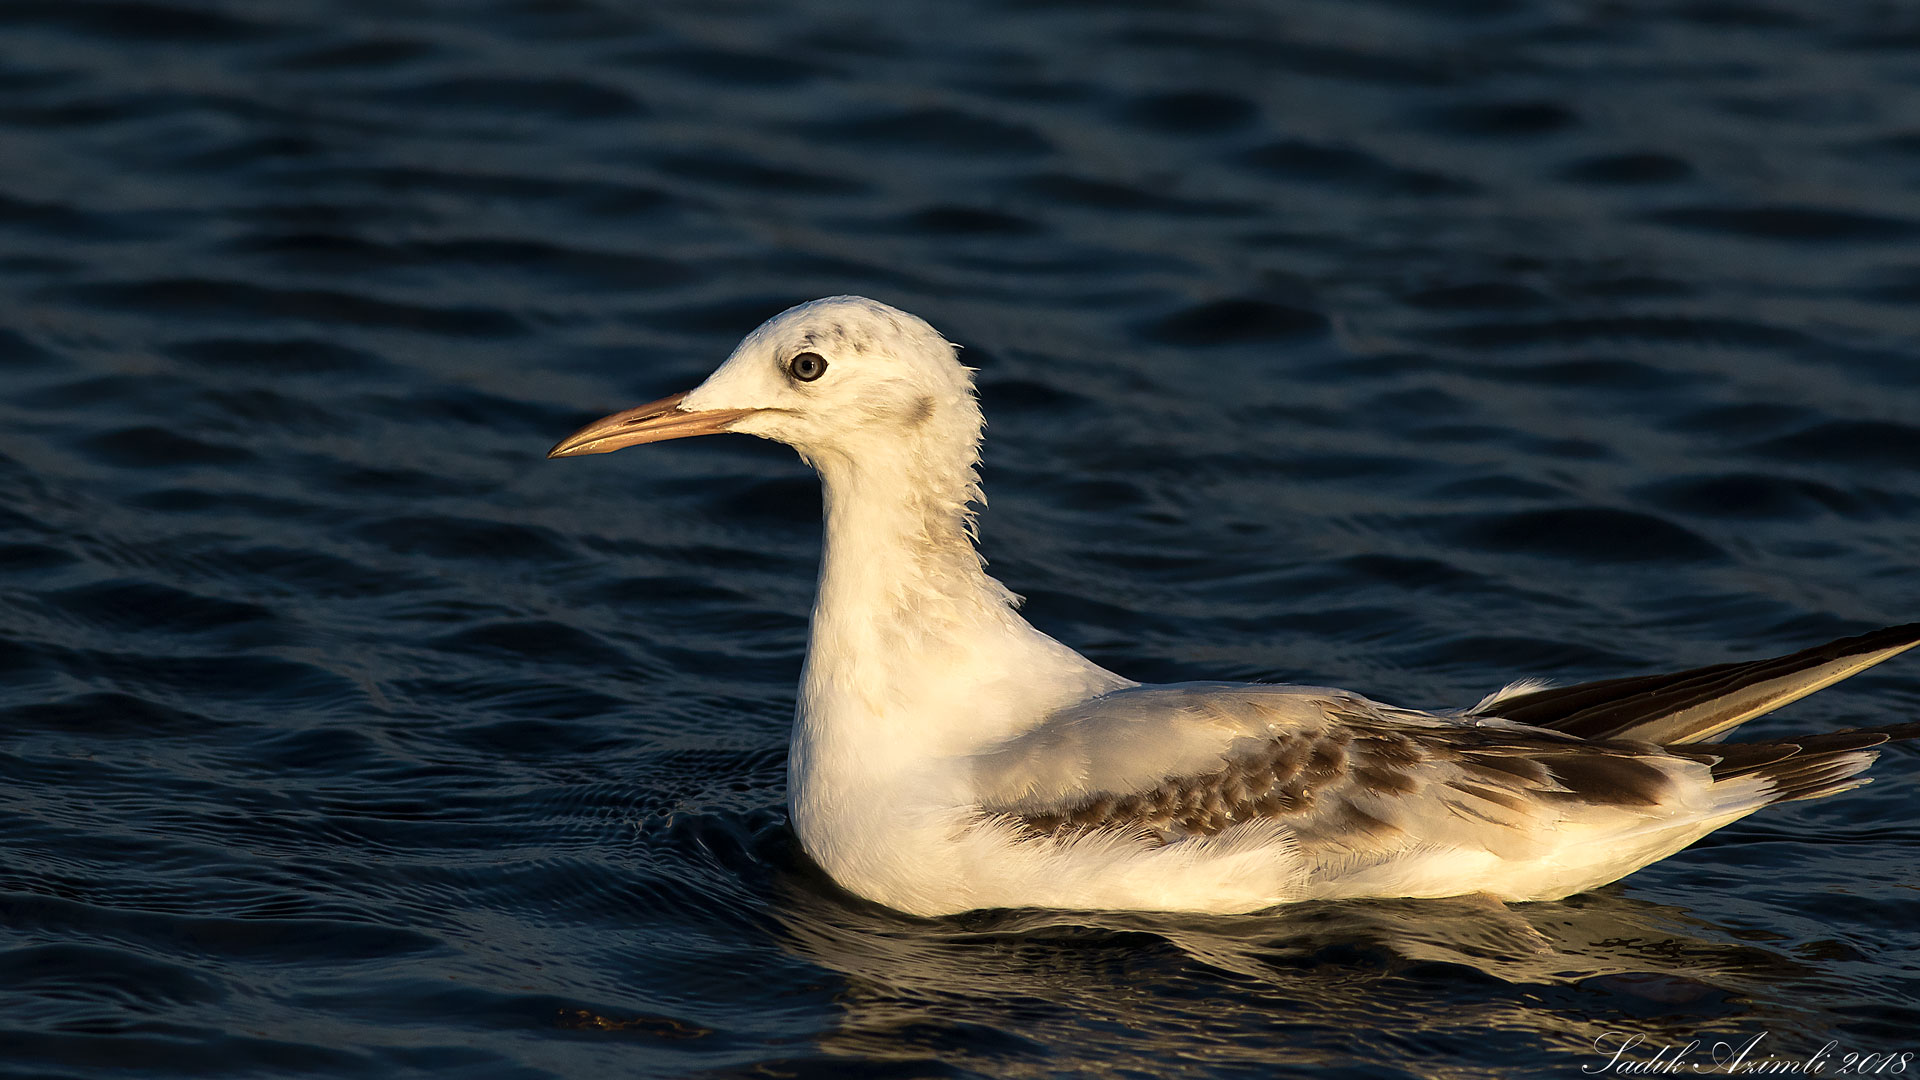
<box><xmin>0</xmin><ymin>0</ymin><xmax>1920</xmax><ymax>1078</ymax></box>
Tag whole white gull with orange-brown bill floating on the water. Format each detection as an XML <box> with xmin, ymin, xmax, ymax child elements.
<box><xmin>549</xmin><ymin>296</ymin><xmax>1920</xmax><ymax>917</ymax></box>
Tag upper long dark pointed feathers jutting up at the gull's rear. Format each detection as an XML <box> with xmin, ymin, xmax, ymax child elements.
<box><xmin>1476</xmin><ymin>623</ymin><xmax>1920</xmax><ymax>746</ymax></box>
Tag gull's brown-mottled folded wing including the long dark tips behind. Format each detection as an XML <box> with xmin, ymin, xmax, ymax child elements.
<box><xmin>981</xmin><ymin>623</ymin><xmax>1920</xmax><ymax>853</ymax></box>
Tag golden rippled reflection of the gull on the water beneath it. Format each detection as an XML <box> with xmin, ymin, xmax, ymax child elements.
<box><xmin>770</xmin><ymin>860</ymin><xmax>1826</xmax><ymax>1076</ymax></box>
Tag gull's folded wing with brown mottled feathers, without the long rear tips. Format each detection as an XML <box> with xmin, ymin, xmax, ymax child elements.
<box><xmin>972</xmin><ymin>684</ymin><xmax>1718</xmax><ymax>859</ymax></box>
